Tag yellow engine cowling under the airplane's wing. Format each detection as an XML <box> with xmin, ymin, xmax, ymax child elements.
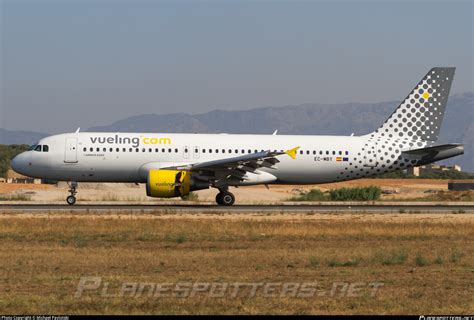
<box><xmin>146</xmin><ymin>170</ymin><xmax>191</xmax><ymax>198</ymax></box>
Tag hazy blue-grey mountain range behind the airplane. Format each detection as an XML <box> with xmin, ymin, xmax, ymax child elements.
<box><xmin>0</xmin><ymin>92</ymin><xmax>474</xmax><ymax>172</ymax></box>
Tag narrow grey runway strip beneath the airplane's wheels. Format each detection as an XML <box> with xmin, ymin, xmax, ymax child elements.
<box><xmin>0</xmin><ymin>203</ymin><xmax>474</xmax><ymax>213</ymax></box>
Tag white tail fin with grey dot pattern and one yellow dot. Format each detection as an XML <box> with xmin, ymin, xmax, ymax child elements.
<box><xmin>371</xmin><ymin>68</ymin><xmax>456</xmax><ymax>141</ymax></box>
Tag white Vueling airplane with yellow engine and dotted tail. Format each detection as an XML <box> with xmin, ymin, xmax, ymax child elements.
<box><xmin>11</xmin><ymin>67</ymin><xmax>464</xmax><ymax>206</ymax></box>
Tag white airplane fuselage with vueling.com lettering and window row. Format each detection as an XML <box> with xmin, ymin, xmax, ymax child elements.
<box><xmin>12</xmin><ymin>132</ymin><xmax>418</xmax><ymax>185</ymax></box>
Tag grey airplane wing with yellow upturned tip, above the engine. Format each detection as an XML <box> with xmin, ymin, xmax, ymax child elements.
<box><xmin>162</xmin><ymin>147</ymin><xmax>299</xmax><ymax>181</ymax></box>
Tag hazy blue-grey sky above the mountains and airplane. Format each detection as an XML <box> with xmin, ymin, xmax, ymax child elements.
<box><xmin>0</xmin><ymin>0</ymin><xmax>474</xmax><ymax>133</ymax></box>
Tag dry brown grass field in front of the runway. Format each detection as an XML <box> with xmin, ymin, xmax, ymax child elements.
<box><xmin>0</xmin><ymin>213</ymin><xmax>474</xmax><ymax>314</ymax></box>
